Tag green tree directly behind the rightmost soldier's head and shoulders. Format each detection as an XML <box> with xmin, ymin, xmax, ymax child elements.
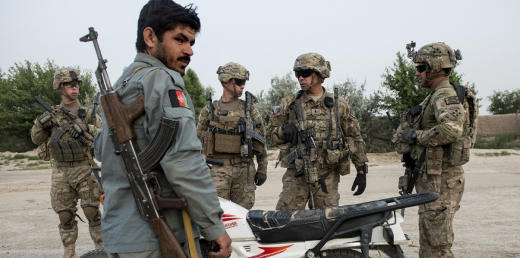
<box><xmin>376</xmin><ymin>52</ymin><xmax>466</xmax><ymax>115</ymax></box>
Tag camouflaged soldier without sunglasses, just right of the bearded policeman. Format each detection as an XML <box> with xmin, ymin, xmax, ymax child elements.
<box><xmin>197</xmin><ymin>62</ymin><xmax>267</xmax><ymax>209</ymax></box>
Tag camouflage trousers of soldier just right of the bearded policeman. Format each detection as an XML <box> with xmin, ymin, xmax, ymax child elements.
<box><xmin>211</xmin><ymin>162</ymin><xmax>256</xmax><ymax>210</ymax></box>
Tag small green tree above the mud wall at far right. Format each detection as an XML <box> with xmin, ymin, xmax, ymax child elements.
<box><xmin>488</xmin><ymin>89</ymin><xmax>520</xmax><ymax>115</ymax></box>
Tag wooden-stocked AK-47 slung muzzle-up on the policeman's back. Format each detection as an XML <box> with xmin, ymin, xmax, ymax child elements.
<box><xmin>80</xmin><ymin>27</ymin><xmax>188</xmax><ymax>258</ymax></box>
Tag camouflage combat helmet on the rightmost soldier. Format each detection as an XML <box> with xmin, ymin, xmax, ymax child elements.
<box><xmin>406</xmin><ymin>41</ymin><xmax>462</xmax><ymax>73</ymax></box>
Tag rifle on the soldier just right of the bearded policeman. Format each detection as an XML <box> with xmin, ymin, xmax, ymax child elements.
<box><xmin>238</xmin><ymin>91</ymin><xmax>265</xmax><ymax>182</ymax></box>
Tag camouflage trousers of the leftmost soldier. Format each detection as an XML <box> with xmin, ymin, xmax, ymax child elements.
<box><xmin>50</xmin><ymin>161</ymin><xmax>103</xmax><ymax>252</ymax></box>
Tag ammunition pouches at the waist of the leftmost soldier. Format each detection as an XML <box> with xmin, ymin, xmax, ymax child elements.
<box><xmin>48</xmin><ymin>129</ymin><xmax>87</xmax><ymax>162</ymax></box>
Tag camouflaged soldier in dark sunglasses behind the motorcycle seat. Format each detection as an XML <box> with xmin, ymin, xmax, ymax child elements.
<box><xmin>269</xmin><ymin>53</ymin><xmax>368</xmax><ymax>210</ymax></box>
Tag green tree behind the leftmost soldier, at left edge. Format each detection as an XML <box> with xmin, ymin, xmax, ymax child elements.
<box><xmin>0</xmin><ymin>60</ymin><xmax>95</xmax><ymax>151</ymax></box>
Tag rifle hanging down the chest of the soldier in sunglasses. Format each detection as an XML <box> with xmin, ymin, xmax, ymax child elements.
<box><xmin>286</xmin><ymin>95</ymin><xmax>318</xmax><ymax>209</ymax></box>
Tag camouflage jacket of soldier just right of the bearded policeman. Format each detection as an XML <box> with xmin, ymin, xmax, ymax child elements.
<box><xmin>197</xmin><ymin>99</ymin><xmax>267</xmax><ymax>174</ymax></box>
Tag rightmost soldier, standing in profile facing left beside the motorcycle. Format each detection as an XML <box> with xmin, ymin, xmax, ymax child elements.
<box><xmin>393</xmin><ymin>42</ymin><xmax>469</xmax><ymax>257</ymax></box>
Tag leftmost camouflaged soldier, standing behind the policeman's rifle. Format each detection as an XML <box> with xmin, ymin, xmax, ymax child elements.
<box><xmin>31</xmin><ymin>68</ymin><xmax>103</xmax><ymax>257</ymax></box>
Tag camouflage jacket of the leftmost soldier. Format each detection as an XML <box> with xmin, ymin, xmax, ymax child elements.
<box><xmin>31</xmin><ymin>102</ymin><xmax>101</xmax><ymax>160</ymax></box>
